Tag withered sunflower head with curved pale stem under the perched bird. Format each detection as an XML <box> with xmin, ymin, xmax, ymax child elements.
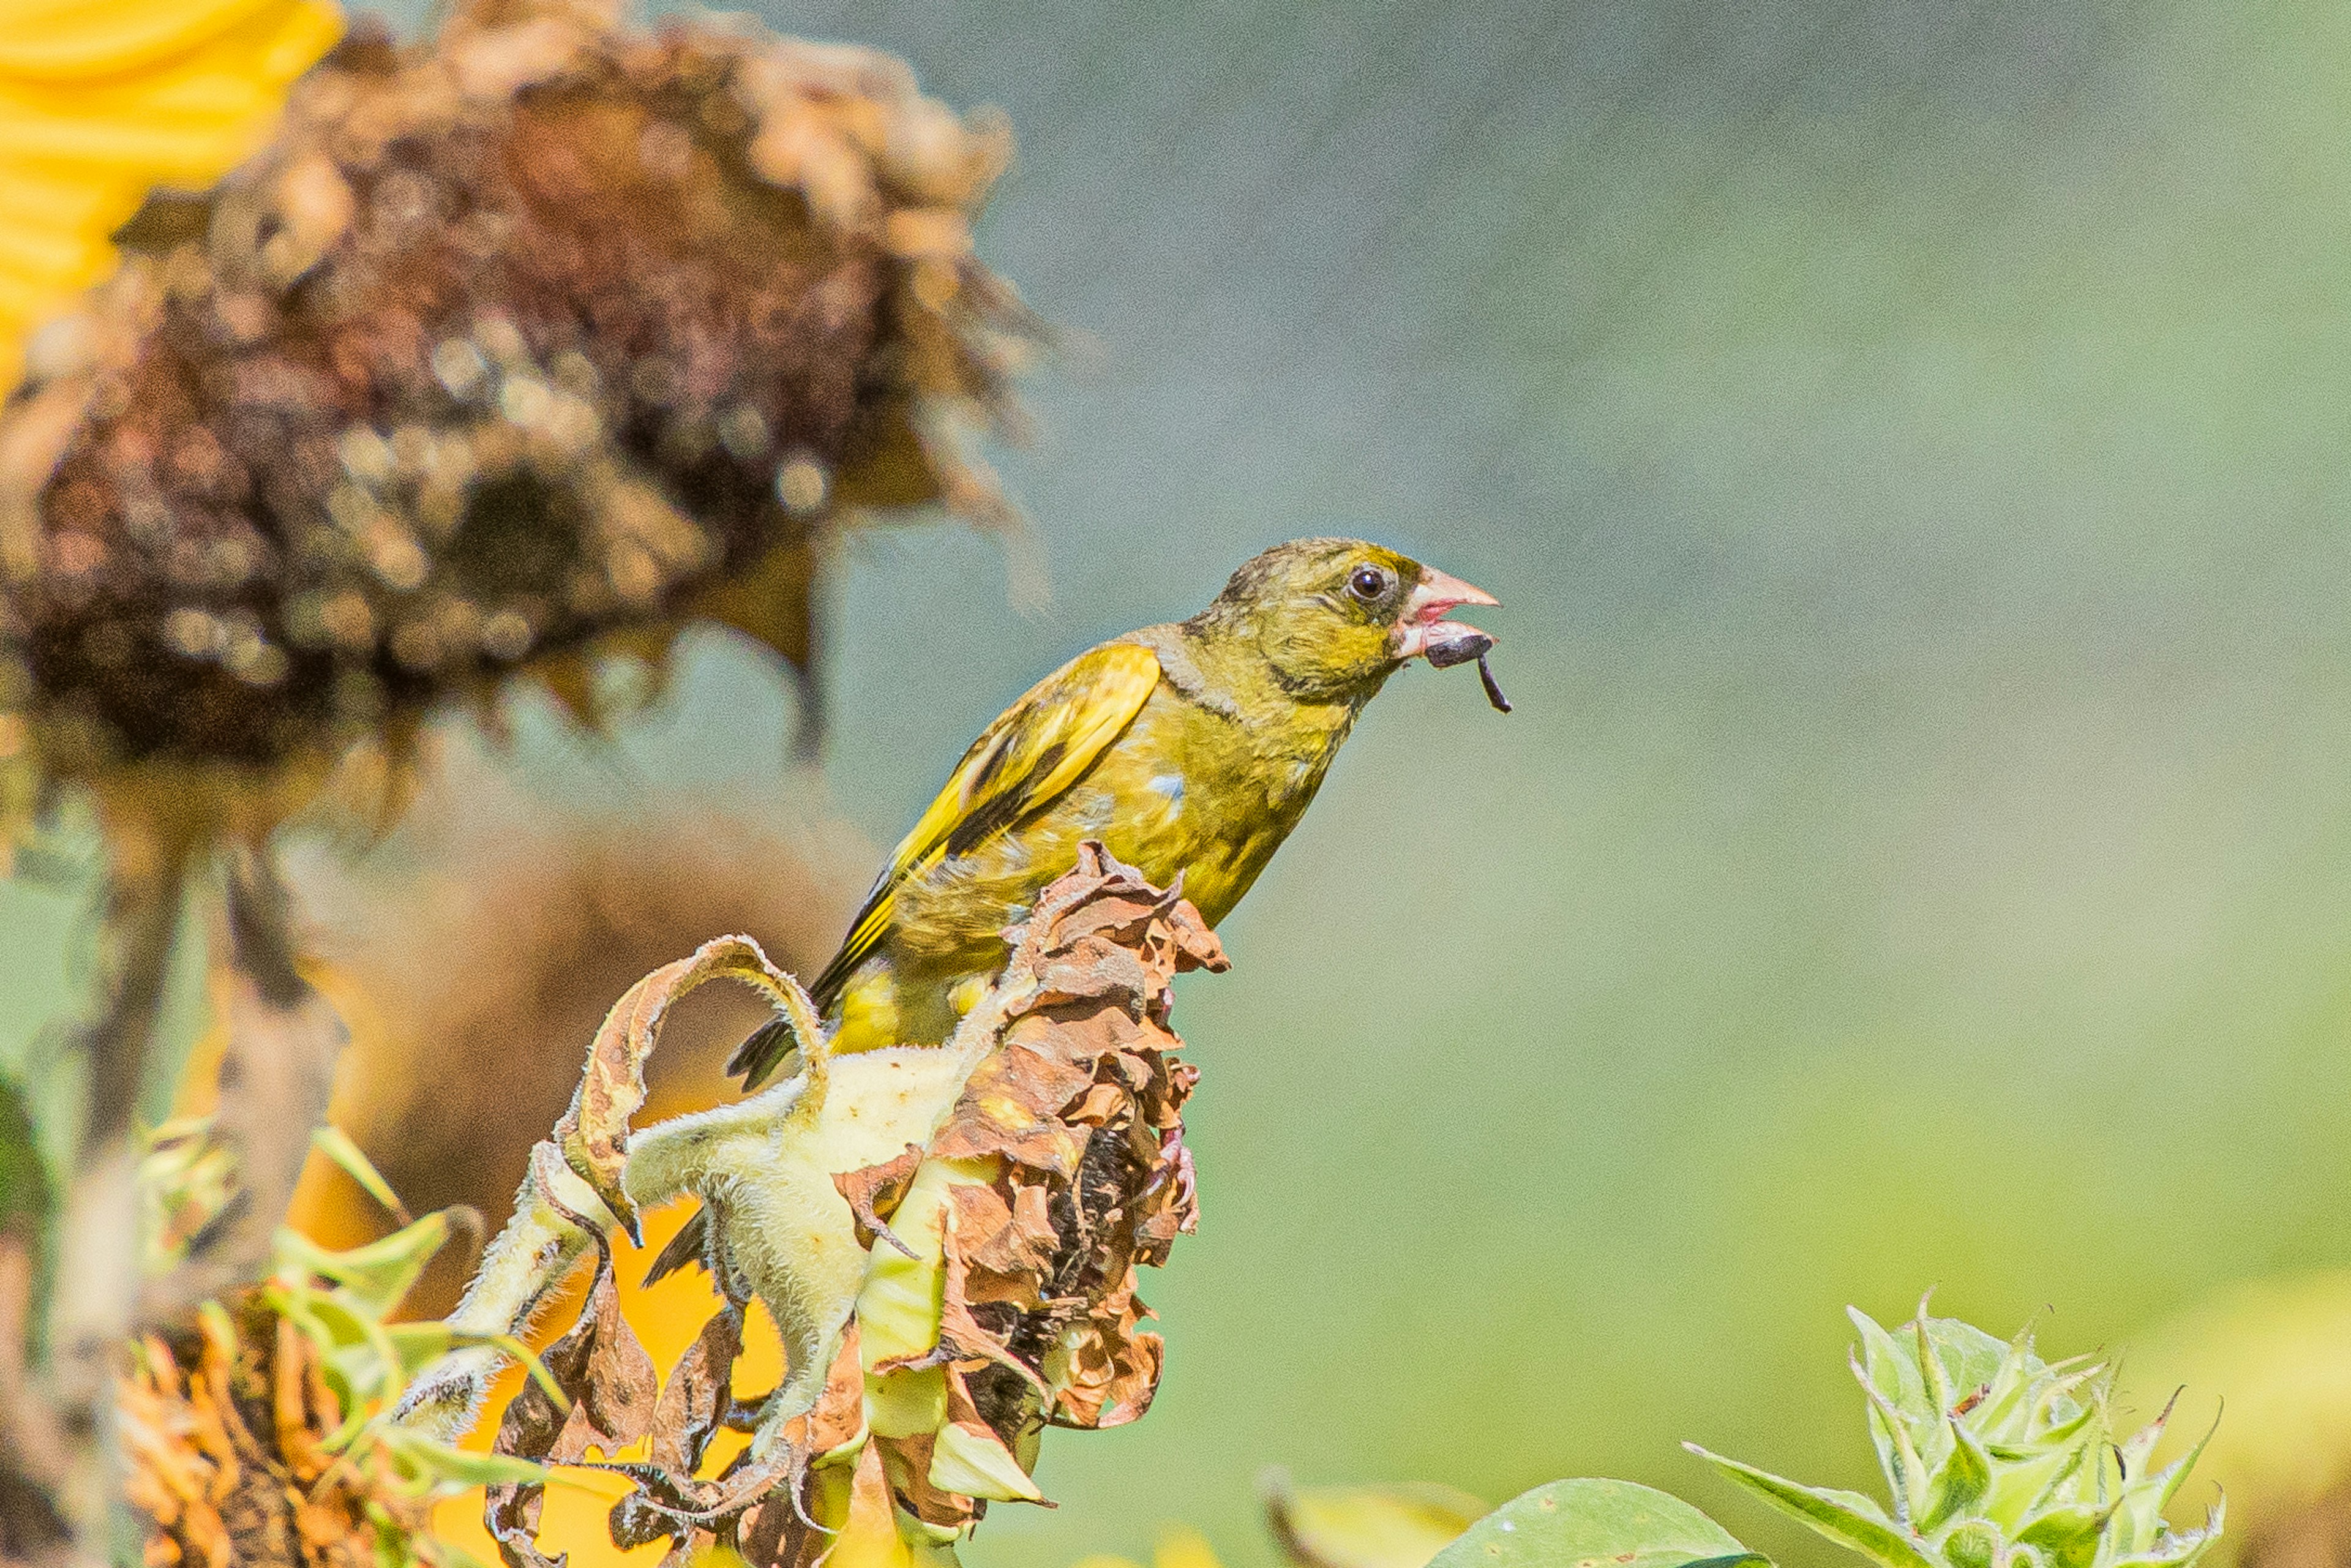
<box><xmin>395</xmin><ymin>844</ymin><xmax>1225</xmax><ymax>1568</ymax></box>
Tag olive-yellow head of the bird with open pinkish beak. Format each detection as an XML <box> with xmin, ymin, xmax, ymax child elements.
<box><xmin>1197</xmin><ymin>538</ymin><xmax>1498</xmax><ymax>698</ymax></box>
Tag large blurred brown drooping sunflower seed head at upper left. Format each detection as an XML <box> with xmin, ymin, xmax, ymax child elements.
<box><xmin>0</xmin><ymin>0</ymin><xmax>1030</xmax><ymax>832</ymax></box>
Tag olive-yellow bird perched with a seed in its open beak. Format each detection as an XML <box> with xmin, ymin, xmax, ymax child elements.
<box><xmin>727</xmin><ymin>538</ymin><xmax>1502</xmax><ymax>1089</ymax></box>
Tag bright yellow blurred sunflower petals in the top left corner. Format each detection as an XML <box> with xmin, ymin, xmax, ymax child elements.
<box><xmin>0</xmin><ymin>0</ymin><xmax>343</xmax><ymax>392</ymax></box>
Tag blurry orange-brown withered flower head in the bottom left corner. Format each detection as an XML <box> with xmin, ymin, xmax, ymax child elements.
<box><xmin>118</xmin><ymin>1296</ymin><xmax>430</xmax><ymax>1568</ymax></box>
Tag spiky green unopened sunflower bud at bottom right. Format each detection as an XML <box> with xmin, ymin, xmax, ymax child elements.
<box><xmin>1690</xmin><ymin>1302</ymin><xmax>2222</xmax><ymax>1568</ymax></box>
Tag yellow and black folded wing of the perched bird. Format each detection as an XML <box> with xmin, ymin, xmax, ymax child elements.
<box><xmin>811</xmin><ymin>642</ymin><xmax>1159</xmax><ymax>1006</ymax></box>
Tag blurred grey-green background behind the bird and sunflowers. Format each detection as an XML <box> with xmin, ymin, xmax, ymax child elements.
<box><xmin>0</xmin><ymin>0</ymin><xmax>2351</xmax><ymax>1568</ymax></box>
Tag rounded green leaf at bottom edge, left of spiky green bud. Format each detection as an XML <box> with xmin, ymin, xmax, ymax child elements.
<box><xmin>1430</xmin><ymin>1481</ymin><xmax>1771</xmax><ymax>1568</ymax></box>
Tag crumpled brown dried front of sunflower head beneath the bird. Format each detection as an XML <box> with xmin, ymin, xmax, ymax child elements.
<box><xmin>842</xmin><ymin>844</ymin><xmax>1227</xmax><ymax>1523</ymax></box>
